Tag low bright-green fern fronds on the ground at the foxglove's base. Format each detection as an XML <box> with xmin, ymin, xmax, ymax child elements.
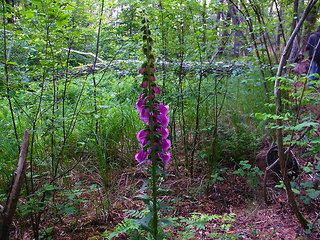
<box><xmin>103</xmin><ymin>210</ymin><xmax>242</xmax><ymax>240</ymax></box>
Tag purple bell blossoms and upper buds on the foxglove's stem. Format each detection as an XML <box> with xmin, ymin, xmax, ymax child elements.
<box><xmin>135</xmin><ymin>34</ymin><xmax>171</xmax><ymax>165</ymax></box>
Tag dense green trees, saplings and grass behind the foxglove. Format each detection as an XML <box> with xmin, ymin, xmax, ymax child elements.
<box><xmin>0</xmin><ymin>0</ymin><xmax>320</xmax><ymax>239</ymax></box>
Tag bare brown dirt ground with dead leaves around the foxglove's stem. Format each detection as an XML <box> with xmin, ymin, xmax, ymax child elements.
<box><xmin>19</xmin><ymin>149</ymin><xmax>320</xmax><ymax>240</ymax></box>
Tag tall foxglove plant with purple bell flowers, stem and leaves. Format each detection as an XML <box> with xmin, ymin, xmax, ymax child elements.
<box><xmin>135</xmin><ymin>15</ymin><xmax>171</xmax><ymax>239</ymax></box>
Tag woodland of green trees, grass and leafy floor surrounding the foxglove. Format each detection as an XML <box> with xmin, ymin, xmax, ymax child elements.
<box><xmin>0</xmin><ymin>0</ymin><xmax>320</xmax><ymax>239</ymax></box>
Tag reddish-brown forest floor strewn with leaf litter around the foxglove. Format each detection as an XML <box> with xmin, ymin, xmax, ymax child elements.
<box><xmin>16</xmin><ymin>87</ymin><xmax>320</xmax><ymax>240</ymax></box>
